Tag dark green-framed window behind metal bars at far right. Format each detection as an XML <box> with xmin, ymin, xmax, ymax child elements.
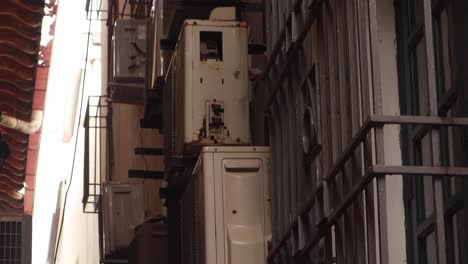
<box><xmin>396</xmin><ymin>0</ymin><xmax>467</xmax><ymax>264</ymax></box>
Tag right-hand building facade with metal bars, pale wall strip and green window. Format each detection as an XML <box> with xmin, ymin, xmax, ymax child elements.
<box><xmin>262</xmin><ymin>0</ymin><xmax>467</xmax><ymax>263</ymax></box>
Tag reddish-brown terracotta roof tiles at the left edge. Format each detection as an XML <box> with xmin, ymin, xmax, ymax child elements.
<box><xmin>0</xmin><ymin>0</ymin><xmax>48</xmax><ymax>214</ymax></box>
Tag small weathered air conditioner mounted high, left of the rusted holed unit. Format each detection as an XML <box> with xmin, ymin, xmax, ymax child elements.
<box><xmin>112</xmin><ymin>19</ymin><xmax>148</xmax><ymax>82</ymax></box>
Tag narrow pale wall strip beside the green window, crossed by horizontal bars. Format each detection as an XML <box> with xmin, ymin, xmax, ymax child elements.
<box><xmin>377</xmin><ymin>0</ymin><xmax>406</xmax><ymax>264</ymax></box>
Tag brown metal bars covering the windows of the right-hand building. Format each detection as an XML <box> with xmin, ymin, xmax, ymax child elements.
<box><xmin>264</xmin><ymin>0</ymin><xmax>468</xmax><ymax>264</ymax></box>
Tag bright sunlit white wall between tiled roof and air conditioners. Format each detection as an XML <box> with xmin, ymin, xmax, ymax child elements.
<box><xmin>32</xmin><ymin>0</ymin><xmax>101</xmax><ymax>264</ymax></box>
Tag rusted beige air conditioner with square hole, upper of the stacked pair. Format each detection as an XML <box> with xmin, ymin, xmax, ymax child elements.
<box><xmin>164</xmin><ymin>20</ymin><xmax>250</xmax><ymax>155</ymax></box>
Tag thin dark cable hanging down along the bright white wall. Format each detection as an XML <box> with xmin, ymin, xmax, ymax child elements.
<box><xmin>53</xmin><ymin>9</ymin><xmax>92</xmax><ymax>264</ymax></box>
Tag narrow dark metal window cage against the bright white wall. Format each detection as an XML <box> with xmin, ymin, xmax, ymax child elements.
<box><xmin>82</xmin><ymin>96</ymin><xmax>112</xmax><ymax>213</ymax></box>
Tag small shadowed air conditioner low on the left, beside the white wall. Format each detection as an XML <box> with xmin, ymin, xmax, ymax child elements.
<box><xmin>102</xmin><ymin>183</ymin><xmax>145</xmax><ymax>256</ymax></box>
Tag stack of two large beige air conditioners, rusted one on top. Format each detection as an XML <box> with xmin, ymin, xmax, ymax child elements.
<box><xmin>164</xmin><ymin>9</ymin><xmax>271</xmax><ymax>264</ymax></box>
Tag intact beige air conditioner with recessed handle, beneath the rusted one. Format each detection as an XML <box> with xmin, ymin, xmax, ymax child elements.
<box><xmin>181</xmin><ymin>147</ymin><xmax>271</xmax><ymax>264</ymax></box>
